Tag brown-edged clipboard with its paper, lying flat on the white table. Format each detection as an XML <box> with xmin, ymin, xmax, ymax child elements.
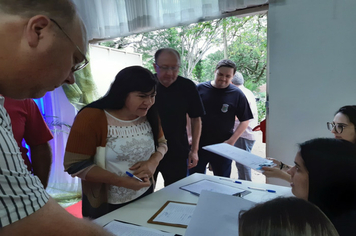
<box><xmin>148</xmin><ymin>201</ymin><xmax>196</xmax><ymax>228</ymax></box>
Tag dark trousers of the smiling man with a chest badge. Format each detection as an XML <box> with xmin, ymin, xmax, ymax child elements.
<box><xmin>189</xmin><ymin>149</ymin><xmax>232</xmax><ymax>178</ymax></box>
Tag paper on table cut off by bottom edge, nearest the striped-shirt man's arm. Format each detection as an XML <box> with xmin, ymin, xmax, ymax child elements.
<box><xmin>104</xmin><ymin>220</ymin><xmax>175</xmax><ymax>236</ymax></box>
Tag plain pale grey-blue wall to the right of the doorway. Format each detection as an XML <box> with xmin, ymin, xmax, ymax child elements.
<box><xmin>267</xmin><ymin>0</ymin><xmax>356</xmax><ymax>185</ymax></box>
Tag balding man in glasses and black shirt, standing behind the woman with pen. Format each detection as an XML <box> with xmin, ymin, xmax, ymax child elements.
<box><xmin>153</xmin><ymin>48</ymin><xmax>204</xmax><ymax>186</ymax></box>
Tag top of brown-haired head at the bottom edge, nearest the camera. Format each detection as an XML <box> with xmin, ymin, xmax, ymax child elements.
<box><xmin>239</xmin><ymin>197</ymin><xmax>339</xmax><ymax>236</ymax></box>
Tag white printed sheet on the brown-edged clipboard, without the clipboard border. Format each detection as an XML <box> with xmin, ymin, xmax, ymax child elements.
<box><xmin>153</xmin><ymin>202</ymin><xmax>196</xmax><ymax>225</ymax></box>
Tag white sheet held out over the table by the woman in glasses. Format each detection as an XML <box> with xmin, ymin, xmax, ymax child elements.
<box><xmin>203</xmin><ymin>143</ymin><xmax>274</xmax><ymax>170</ymax></box>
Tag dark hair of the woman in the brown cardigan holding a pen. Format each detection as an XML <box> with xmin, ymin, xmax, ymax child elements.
<box><xmin>83</xmin><ymin>66</ymin><xmax>159</xmax><ymax>147</ymax></box>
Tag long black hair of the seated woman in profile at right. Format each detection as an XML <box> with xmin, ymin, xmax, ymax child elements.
<box><xmin>299</xmin><ymin>138</ymin><xmax>356</xmax><ymax>234</ymax></box>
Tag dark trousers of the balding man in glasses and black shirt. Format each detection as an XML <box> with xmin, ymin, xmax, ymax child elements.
<box><xmin>153</xmin><ymin>149</ymin><xmax>188</xmax><ymax>187</ymax></box>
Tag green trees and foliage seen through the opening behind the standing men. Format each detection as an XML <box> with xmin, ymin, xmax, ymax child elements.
<box><xmin>101</xmin><ymin>14</ymin><xmax>267</xmax><ymax>121</ymax></box>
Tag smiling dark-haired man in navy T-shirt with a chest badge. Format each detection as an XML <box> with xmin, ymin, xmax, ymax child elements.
<box><xmin>190</xmin><ymin>60</ymin><xmax>253</xmax><ymax>177</ymax></box>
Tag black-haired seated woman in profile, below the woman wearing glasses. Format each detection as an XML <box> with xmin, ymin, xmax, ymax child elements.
<box><xmin>288</xmin><ymin>138</ymin><xmax>356</xmax><ymax>235</ymax></box>
